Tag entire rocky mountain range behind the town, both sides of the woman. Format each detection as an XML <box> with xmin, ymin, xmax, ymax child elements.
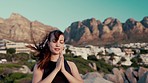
<box><xmin>0</xmin><ymin>13</ymin><xmax>148</xmax><ymax>45</ymax></box>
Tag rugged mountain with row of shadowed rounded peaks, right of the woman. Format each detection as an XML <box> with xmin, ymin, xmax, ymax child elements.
<box><xmin>64</xmin><ymin>16</ymin><xmax>148</xmax><ymax>45</ymax></box>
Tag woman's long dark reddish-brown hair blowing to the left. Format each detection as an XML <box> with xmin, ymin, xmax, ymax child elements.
<box><xmin>28</xmin><ymin>30</ymin><xmax>64</xmax><ymax>69</ymax></box>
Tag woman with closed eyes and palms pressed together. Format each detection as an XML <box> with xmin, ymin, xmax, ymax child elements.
<box><xmin>32</xmin><ymin>30</ymin><xmax>83</xmax><ymax>83</ymax></box>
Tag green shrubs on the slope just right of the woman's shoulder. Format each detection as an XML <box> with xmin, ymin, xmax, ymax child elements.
<box><xmin>64</xmin><ymin>55</ymin><xmax>114</xmax><ymax>74</ymax></box>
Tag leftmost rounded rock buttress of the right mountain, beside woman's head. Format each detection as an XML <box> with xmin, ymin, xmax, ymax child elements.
<box><xmin>64</xmin><ymin>22</ymin><xmax>92</xmax><ymax>43</ymax></box>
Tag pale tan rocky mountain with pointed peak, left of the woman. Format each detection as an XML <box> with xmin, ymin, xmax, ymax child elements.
<box><xmin>0</xmin><ymin>13</ymin><xmax>57</xmax><ymax>43</ymax></box>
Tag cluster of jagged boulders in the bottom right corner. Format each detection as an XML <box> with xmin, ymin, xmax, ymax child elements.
<box><xmin>104</xmin><ymin>67</ymin><xmax>148</xmax><ymax>83</ymax></box>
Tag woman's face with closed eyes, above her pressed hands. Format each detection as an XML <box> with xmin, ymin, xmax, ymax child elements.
<box><xmin>48</xmin><ymin>35</ymin><xmax>64</xmax><ymax>55</ymax></box>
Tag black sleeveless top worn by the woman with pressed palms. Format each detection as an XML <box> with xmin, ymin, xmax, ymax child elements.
<box><xmin>42</xmin><ymin>60</ymin><xmax>71</xmax><ymax>83</ymax></box>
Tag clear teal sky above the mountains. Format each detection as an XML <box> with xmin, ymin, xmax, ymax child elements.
<box><xmin>0</xmin><ymin>0</ymin><xmax>148</xmax><ymax>31</ymax></box>
